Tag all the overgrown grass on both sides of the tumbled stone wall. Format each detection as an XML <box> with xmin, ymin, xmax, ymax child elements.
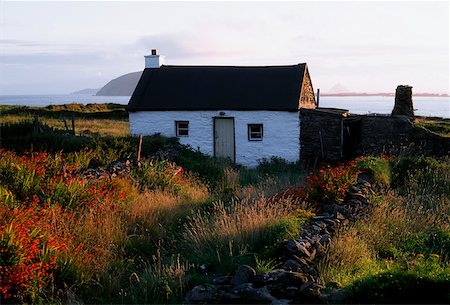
<box><xmin>0</xmin><ymin>105</ymin><xmax>450</xmax><ymax>304</ymax></box>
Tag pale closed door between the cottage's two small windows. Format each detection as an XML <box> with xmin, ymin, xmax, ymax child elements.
<box><xmin>214</xmin><ymin>118</ymin><xmax>235</xmax><ymax>162</ymax></box>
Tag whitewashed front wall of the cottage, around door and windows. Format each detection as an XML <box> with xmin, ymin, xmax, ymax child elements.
<box><xmin>130</xmin><ymin>110</ymin><xmax>300</xmax><ymax>167</ymax></box>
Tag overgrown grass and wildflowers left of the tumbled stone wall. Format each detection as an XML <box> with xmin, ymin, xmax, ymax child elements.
<box><xmin>0</xmin><ymin>107</ymin><xmax>312</xmax><ymax>303</ymax></box>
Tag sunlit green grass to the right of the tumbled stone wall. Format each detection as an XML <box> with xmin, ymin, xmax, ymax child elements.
<box><xmin>320</xmin><ymin>158</ymin><xmax>450</xmax><ymax>303</ymax></box>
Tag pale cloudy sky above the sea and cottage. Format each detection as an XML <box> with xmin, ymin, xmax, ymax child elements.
<box><xmin>0</xmin><ymin>0</ymin><xmax>450</xmax><ymax>95</ymax></box>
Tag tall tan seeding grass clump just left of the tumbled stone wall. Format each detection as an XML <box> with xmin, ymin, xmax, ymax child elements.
<box><xmin>183</xmin><ymin>198</ymin><xmax>300</xmax><ymax>272</ymax></box>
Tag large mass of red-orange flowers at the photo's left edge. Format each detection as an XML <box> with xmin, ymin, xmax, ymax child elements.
<box><xmin>0</xmin><ymin>149</ymin><xmax>132</xmax><ymax>302</ymax></box>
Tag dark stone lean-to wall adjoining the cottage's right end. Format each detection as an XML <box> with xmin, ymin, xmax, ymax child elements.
<box><xmin>300</xmin><ymin>108</ymin><xmax>346</xmax><ymax>160</ymax></box>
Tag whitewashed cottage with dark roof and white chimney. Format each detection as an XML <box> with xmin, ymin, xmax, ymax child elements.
<box><xmin>127</xmin><ymin>50</ymin><xmax>315</xmax><ymax>167</ymax></box>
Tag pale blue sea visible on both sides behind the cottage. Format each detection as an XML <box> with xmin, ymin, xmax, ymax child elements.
<box><xmin>0</xmin><ymin>94</ymin><xmax>450</xmax><ymax>118</ymax></box>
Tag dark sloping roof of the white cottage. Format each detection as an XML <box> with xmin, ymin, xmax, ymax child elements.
<box><xmin>127</xmin><ymin>63</ymin><xmax>307</xmax><ymax>111</ymax></box>
